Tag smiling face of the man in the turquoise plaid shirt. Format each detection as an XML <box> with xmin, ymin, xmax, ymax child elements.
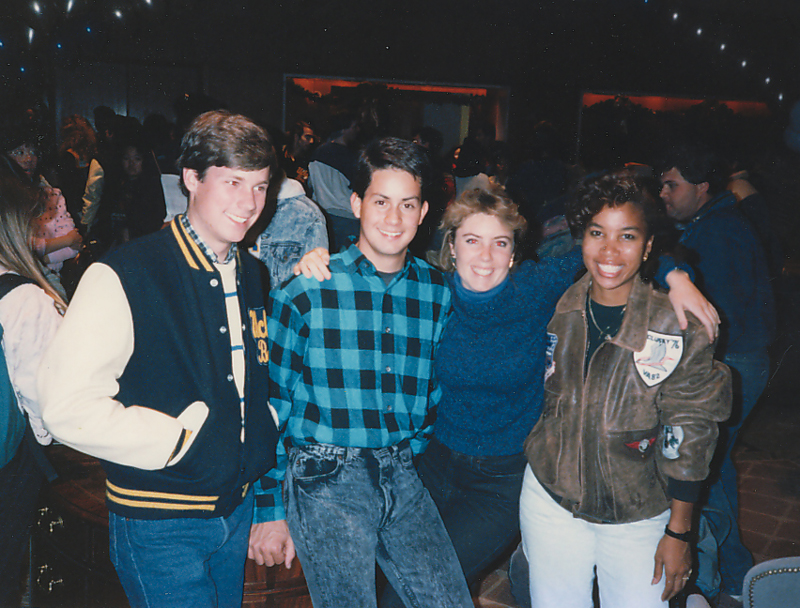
<box><xmin>350</xmin><ymin>169</ymin><xmax>428</xmax><ymax>272</ymax></box>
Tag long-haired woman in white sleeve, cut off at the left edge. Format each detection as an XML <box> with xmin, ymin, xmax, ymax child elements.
<box><xmin>0</xmin><ymin>176</ymin><xmax>66</xmax><ymax>606</ymax></box>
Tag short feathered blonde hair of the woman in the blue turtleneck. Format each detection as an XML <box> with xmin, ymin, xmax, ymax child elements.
<box><xmin>437</xmin><ymin>185</ymin><xmax>528</xmax><ymax>272</ymax></box>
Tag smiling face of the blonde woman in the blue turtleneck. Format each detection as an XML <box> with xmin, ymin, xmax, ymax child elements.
<box><xmin>450</xmin><ymin>213</ymin><xmax>514</xmax><ymax>292</ymax></box>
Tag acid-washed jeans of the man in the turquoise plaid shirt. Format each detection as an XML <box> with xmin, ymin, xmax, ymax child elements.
<box><xmin>285</xmin><ymin>442</ymin><xmax>473</xmax><ymax>608</ymax></box>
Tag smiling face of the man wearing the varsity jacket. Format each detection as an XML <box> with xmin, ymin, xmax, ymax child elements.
<box><xmin>183</xmin><ymin>167</ymin><xmax>269</xmax><ymax>260</ymax></box>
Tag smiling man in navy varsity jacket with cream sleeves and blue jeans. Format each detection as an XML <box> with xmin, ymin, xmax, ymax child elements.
<box><xmin>39</xmin><ymin>112</ymin><xmax>280</xmax><ymax>608</ymax></box>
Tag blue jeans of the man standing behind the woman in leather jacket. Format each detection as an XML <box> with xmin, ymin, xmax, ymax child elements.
<box><xmin>697</xmin><ymin>353</ymin><xmax>769</xmax><ymax>597</ymax></box>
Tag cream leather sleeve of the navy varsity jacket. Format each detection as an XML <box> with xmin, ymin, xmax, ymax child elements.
<box><xmin>38</xmin><ymin>264</ymin><xmax>208</xmax><ymax>470</ymax></box>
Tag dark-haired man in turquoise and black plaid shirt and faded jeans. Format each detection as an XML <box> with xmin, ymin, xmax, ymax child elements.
<box><xmin>250</xmin><ymin>138</ymin><xmax>472</xmax><ymax>608</ymax></box>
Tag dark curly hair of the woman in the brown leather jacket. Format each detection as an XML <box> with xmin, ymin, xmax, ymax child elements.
<box><xmin>566</xmin><ymin>170</ymin><xmax>674</xmax><ymax>280</ymax></box>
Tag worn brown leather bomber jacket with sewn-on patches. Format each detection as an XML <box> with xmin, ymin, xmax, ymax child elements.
<box><xmin>525</xmin><ymin>274</ymin><xmax>731</xmax><ymax>523</ymax></box>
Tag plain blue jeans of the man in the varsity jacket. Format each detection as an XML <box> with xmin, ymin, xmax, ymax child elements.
<box><xmin>108</xmin><ymin>490</ymin><xmax>253</xmax><ymax>608</ymax></box>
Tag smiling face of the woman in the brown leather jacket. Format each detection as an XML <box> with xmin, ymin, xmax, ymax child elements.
<box><xmin>583</xmin><ymin>203</ymin><xmax>653</xmax><ymax>306</ymax></box>
